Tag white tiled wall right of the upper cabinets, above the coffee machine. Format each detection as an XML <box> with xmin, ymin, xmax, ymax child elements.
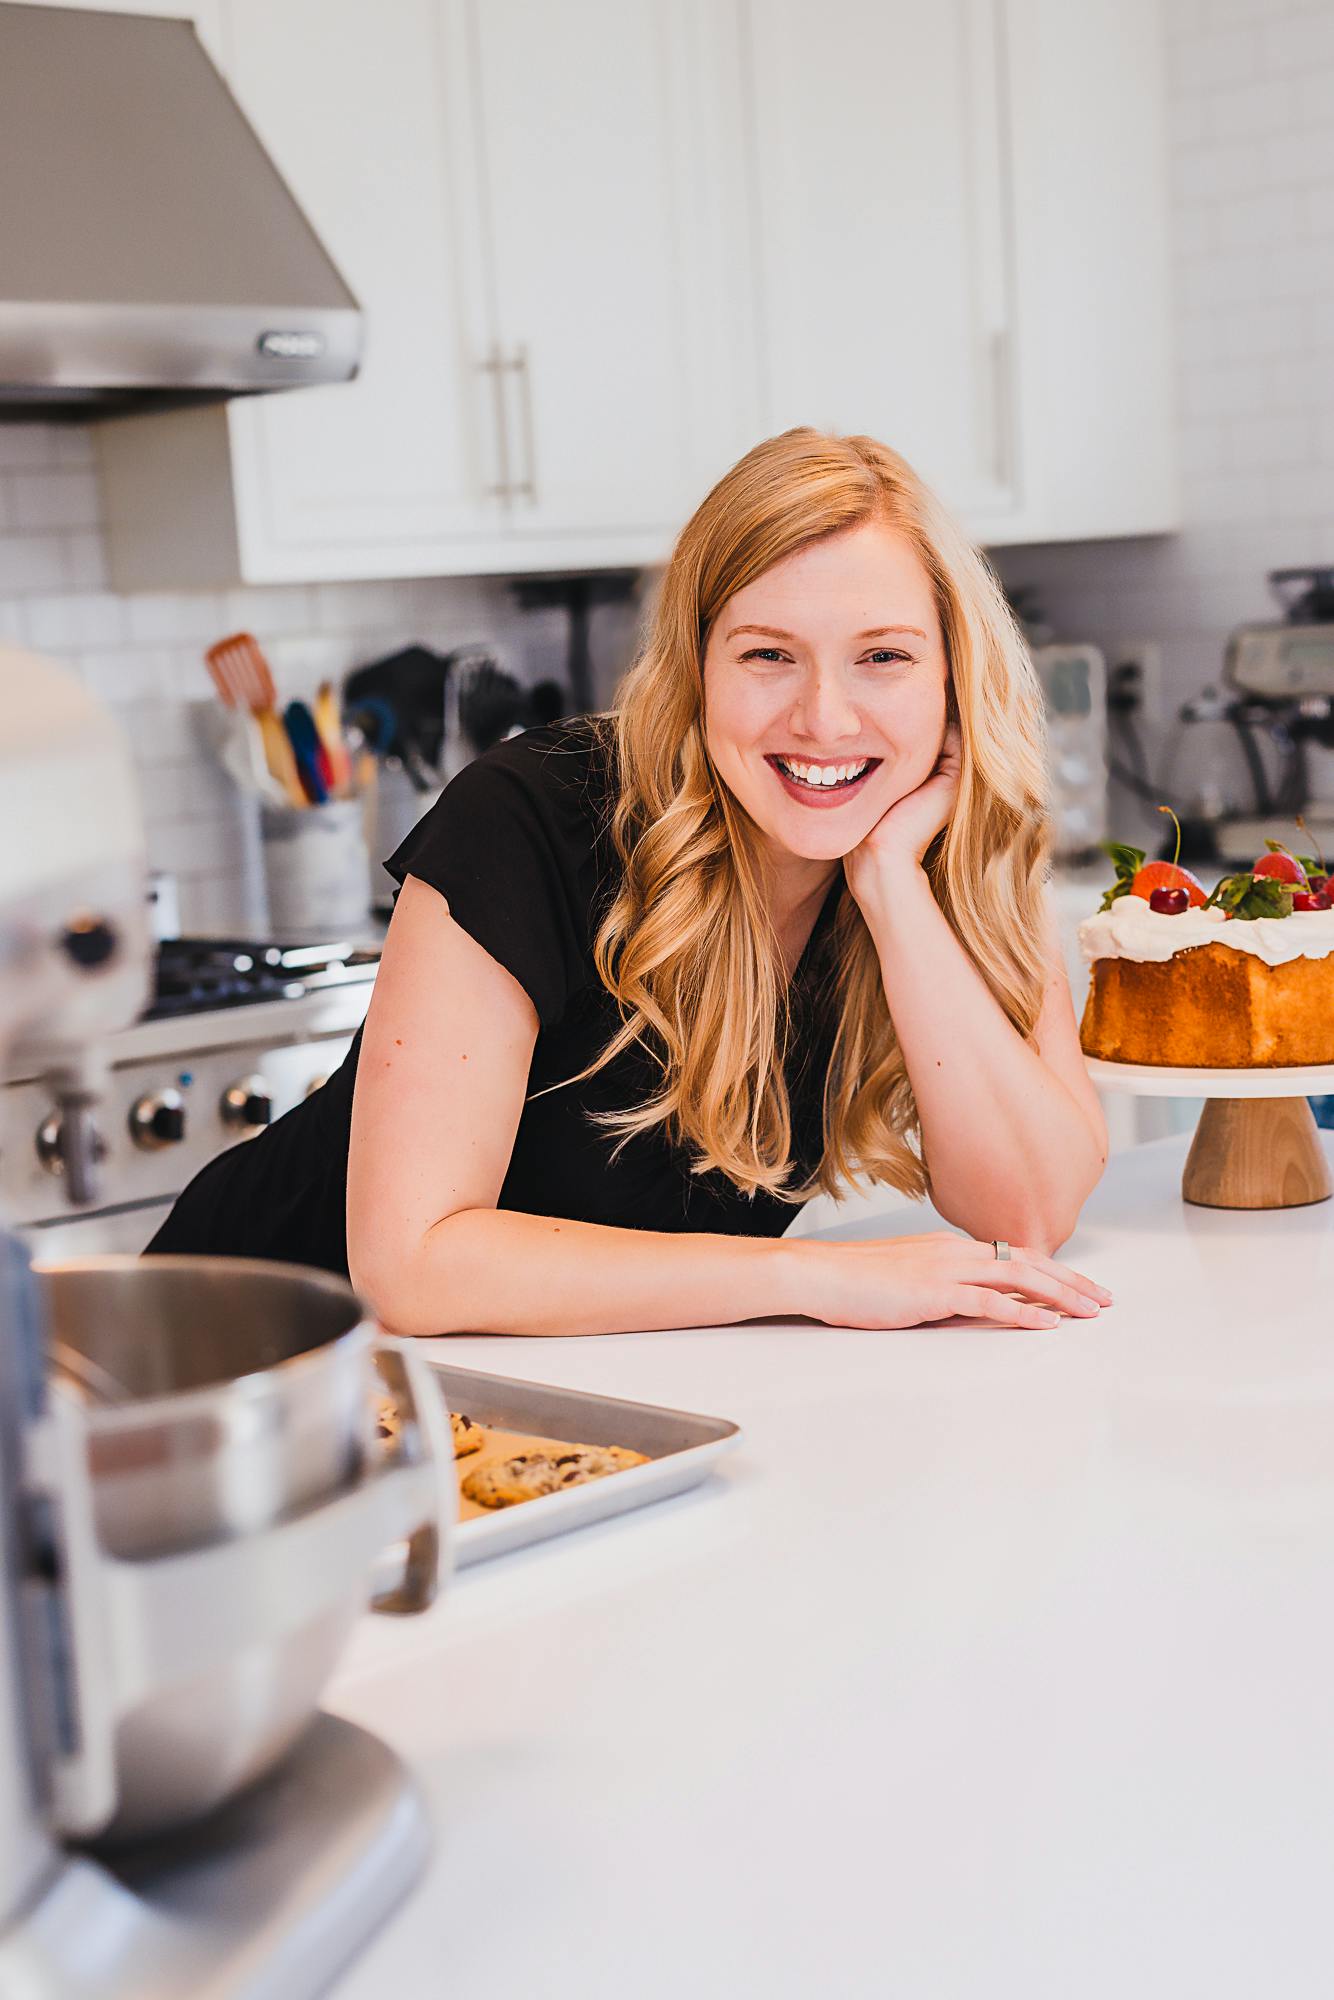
<box><xmin>996</xmin><ymin>0</ymin><xmax>1334</xmax><ymax>840</ymax></box>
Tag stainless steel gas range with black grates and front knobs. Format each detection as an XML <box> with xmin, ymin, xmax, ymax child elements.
<box><xmin>0</xmin><ymin>938</ymin><xmax>380</xmax><ymax>1258</ymax></box>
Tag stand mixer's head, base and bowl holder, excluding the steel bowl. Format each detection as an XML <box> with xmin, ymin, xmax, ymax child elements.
<box><xmin>0</xmin><ymin>648</ymin><xmax>454</xmax><ymax>2000</ymax></box>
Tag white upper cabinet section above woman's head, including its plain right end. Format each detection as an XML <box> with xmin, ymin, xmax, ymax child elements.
<box><xmin>746</xmin><ymin>0</ymin><xmax>1176</xmax><ymax>542</ymax></box>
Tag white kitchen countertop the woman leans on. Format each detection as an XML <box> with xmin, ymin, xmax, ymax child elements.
<box><xmin>330</xmin><ymin>1134</ymin><xmax>1334</xmax><ymax>2000</ymax></box>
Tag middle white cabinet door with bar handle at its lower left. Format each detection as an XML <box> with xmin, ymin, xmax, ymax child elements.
<box><xmin>448</xmin><ymin>0</ymin><xmax>730</xmax><ymax>538</ymax></box>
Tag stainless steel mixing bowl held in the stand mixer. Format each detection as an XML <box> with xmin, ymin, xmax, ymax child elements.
<box><xmin>40</xmin><ymin>1258</ymin><xmax>444</xmax><ymax>1840</ymax></box>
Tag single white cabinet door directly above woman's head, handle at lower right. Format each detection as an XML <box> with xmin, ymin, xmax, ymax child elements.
<box><xmin>748</xmin><ymin>0</ymin><xmax>1016</xmax><ymax>518</ymax></box>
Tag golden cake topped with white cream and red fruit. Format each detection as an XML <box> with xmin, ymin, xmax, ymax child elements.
<box><xmin>1080</xmin><ymin>808</ymin><xmax>1334</xmax><ymax>1070</ymax></box>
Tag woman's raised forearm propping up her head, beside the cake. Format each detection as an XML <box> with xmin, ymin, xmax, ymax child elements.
<box><xmin>868</xmin><ymin>866</ymin><xmax>1104</xmax><ymax>1254</ymax></box>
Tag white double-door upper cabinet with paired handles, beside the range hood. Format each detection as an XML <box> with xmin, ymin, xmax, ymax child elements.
<box><xmin>100</xmin><ymin>0</ymin><xmax>758</xmax><ymax>588</ymax></box>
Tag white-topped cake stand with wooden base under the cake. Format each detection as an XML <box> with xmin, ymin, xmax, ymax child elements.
<box><xmin>1086</xmin><ymin>1056</ymin><xmax>1334</xmax><ymax>1208</ymax></box>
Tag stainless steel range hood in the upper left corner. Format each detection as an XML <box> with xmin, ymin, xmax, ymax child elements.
<box><xmin>0</xmin><ymin>4</ymin><xmax>360</xmax><ymax>418</ymax></box>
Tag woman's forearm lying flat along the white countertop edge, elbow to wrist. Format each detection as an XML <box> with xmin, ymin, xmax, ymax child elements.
<box><xmin>352</xmin><ymin>1208</ymin><xmax>806</xmax><ymax>1334</ymax></box>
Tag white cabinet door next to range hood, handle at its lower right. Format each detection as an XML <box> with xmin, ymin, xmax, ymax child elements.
<box><xmin>224</xmin><ymin>0</ymin><xmax>500</xmax><ymax>576</ymax></box>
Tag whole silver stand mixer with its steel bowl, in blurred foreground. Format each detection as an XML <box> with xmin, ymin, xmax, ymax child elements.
<box><xmin>0</xmin><ymin>646</ymin><xmax>454</xmax><ymax>2000</ymax></box>
